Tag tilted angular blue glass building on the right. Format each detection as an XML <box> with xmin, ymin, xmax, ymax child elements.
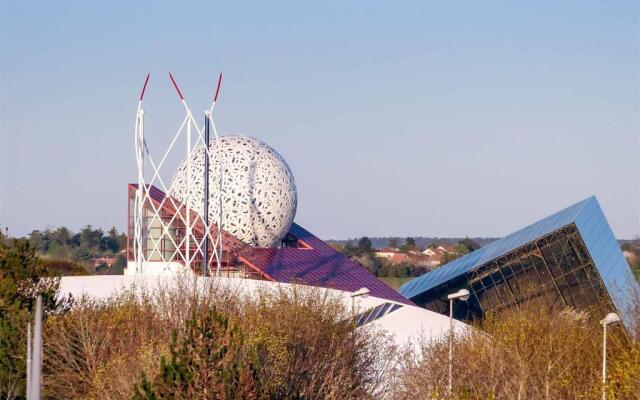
<box><xmin>400</xmin><ymin>196</ymin><xmax>639</xmax><ymax>328</ymax></box>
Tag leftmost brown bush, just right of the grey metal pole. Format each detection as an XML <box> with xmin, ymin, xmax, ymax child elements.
<box><xmin>44</xmin><ymin>292</ymin><xmax>162</xmax><ymax>399</ymax></box>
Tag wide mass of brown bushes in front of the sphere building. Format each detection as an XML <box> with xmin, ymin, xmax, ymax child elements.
<box><xmin>44</xmin><ymin>278</ymin><xmax>395</xmax><ymax>399</ymax></box>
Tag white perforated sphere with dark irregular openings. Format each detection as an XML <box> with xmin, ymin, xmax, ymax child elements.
<box><xmin>171</xmin><ymin>135</ymin><xmax>297</xmax><ymax>247</ymax></box>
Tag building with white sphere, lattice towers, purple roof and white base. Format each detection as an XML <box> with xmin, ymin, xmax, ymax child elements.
<box><xmin>119</xmin><ymin>89</ymin><xmax>468</xmax><ymax>346</ymax></box>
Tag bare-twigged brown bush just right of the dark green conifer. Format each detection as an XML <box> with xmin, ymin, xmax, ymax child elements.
<box><xmin>243</xmin><ymin>287</ymin><xmax>393</xmax><ymax>399</ymax></box>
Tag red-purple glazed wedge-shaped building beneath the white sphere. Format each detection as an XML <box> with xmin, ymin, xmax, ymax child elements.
<box><xmin>125</xmin><ymin>184</ymin><xmax>411</xmax><ymax>304</ymax></box>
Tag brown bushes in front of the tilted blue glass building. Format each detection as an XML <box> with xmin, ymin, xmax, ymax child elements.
<box><xmin>397</xmin><ymin>302</ymin><xmax>640</xmax><ymax>400</ymax></box>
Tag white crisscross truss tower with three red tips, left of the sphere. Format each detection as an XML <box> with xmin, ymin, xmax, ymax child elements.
<box><xmin>132</xmin><ymin>73</ymin><xmax>224</xmax><ymax>275</ymax></box>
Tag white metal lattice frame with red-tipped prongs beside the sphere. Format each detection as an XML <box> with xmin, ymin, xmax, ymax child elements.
<box><xmin>133</xmin><ymin>74</ymin><xmax>224</xmax><ymax>274</ymax></box>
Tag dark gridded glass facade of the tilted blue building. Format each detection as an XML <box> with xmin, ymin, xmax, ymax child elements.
<box><xmin>413</xmin><ymin>224</ymin><xmax>613</xmax><ymax>321</ymax></box>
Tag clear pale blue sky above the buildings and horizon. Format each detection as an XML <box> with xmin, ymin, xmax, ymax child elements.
<box><xmin>0</xmin><ymin>1</ymin><xmax>640</xmax><ymax>238</ymax></box>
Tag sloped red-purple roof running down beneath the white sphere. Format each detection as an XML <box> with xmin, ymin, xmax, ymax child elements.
<box><xmin>129</xmin><ymin>184</ymin><xmax>413</xmax><ymax>304</ymax></box>
